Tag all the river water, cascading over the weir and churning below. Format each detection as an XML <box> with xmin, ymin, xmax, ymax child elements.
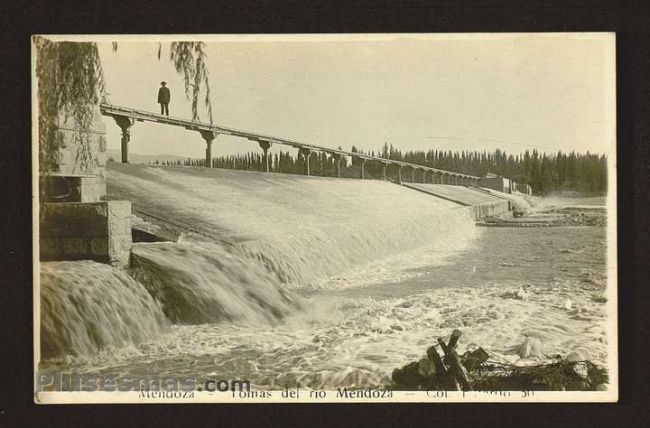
<box><xmin>41</xmin><ymin>168</ymin><xmax>607</xmax><ymax>389</ymax></box>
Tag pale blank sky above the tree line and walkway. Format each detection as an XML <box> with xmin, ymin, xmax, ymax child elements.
<box><xmin>85</xmin><ymin>33</ymin><xmax>615</xmax><ymax>157</ymax></box>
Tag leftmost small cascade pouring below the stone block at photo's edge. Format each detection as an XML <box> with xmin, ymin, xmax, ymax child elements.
<box><xmin>41</xmin><ymin>261</ymin><xmax>168</xmax><ymax>358</ymax></box>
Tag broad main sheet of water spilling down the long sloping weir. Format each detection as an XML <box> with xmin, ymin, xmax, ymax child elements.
<box><xmin>109</xmin><ymin>165</ymin><xmax>476</xmax><ymax>288</ymax></box>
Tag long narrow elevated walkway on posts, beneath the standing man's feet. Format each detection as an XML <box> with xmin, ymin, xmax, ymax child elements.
<box><xmin>100</xmin><ymin>103</ymin><xmax>480</xmax><ymax>185</ymax></box>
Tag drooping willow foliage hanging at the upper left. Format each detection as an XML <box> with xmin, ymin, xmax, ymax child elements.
<box><xmin>34</xmin><ymin>36</ymin><xmax>213</xmax><ymax>173</ymax></box>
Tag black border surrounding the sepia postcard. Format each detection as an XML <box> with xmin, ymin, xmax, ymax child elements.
<box><xmin>0</xmin><ymin>0</ymin><xmax>650</xmax><ymax>428</ymax></box>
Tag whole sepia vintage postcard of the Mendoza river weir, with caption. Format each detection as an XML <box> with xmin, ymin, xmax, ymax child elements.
<box><xmin>32</xmin><ymin>33</ymin><xmax>618</xmax><ymax>404</ymax></box>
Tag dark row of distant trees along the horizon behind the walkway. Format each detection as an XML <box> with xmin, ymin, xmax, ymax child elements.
<box><xmin>144</xmin><ymin>143</ymin><xmax>607</xmax><ymax>195</ymax></box>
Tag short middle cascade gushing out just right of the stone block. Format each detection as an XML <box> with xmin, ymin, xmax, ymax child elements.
<box><xmin>131</xmin><ymin>237</ymin><xmax>300</xmax><ymax>324</ymax></box>
